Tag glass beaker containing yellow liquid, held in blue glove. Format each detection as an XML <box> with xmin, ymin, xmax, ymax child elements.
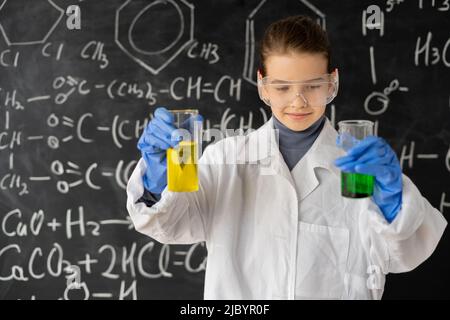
<box><xmin>167</xmin><ymin>109</ymin><xmax>202</xmax><ymax>192</ymax></box>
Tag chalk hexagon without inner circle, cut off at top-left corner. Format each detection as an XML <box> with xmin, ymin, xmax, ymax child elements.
<box><xmin>0</xmin><ymin>0</ymin><xmax>64</xmax><ymax>46</ymax></box>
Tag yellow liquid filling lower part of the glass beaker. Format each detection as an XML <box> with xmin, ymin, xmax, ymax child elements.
<box><xmin>167</xmin><ymin>141</ymin><xmax>198</xmax><ymax>192</ymax></box>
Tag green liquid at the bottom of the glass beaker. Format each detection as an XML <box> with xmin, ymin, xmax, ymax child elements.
<box><xmin>341</xmin><ymin>172</ymin><xmax>375</xmax><ymax>198</ymax></box>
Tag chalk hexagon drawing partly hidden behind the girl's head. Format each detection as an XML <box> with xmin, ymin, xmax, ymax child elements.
<box><xmin>242</xmin><ymin>0</ymin><xmax>326</xmax><ymax>86</ymax></box>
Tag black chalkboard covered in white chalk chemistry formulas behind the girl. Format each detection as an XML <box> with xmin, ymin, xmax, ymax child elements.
<box><xmin>0</xmin><ymin>0</ymin><xmax>450</xmax><ymax>299</ymax></box>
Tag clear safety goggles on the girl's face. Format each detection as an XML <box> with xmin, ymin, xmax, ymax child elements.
<box><xmin>258</xmin><ymin>70</ymin><xmax>339</xmax><ymax>108</ymax></box>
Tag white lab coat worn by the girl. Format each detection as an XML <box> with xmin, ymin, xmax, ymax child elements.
<box><xmin>127</xmin><ymin>118</ymin><xmax>447</xmax><ymax>299</ymax></box>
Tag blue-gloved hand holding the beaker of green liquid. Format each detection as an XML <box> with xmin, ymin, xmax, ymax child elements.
<box><xmin>334</xmin><ymin>136</ymin><xmax>402</xmax><ymax>223</ymax></box>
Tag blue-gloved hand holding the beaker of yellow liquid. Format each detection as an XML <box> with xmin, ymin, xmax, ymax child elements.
<box><xmin>137</xmin><ymin>107</ymin><xmax>203</xmax><ymax>194</ymax></box>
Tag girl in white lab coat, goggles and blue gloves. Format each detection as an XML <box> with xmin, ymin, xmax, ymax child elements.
<box><xmin>127</xmin><ymin>16</ymin><xmax>447</xmax><ymax>299</ymax></box>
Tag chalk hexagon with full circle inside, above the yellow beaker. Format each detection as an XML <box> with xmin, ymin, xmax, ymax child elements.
<box><xmin>114</xmin><ymin>0</ymin><xmax>194</xmax><ymax>75</ymax></box>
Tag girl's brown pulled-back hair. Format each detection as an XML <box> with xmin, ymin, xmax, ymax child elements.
<box><xmin>259</xmin><ymin>15</ymin><xmax>331</xmax><ymax>76</ymax></box>
